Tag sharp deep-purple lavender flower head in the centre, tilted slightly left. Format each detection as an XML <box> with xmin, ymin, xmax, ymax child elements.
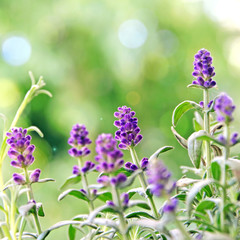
<box><xmin>114</xmin><ymin>106</ymin><xmax>142</xmax><ymax>149</ymax></box>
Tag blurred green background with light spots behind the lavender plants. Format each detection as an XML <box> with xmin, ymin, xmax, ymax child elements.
<box><xmin>0</xmin><ymin>0</ymin><xmax>240</xmax><ymax>239</ymax></box>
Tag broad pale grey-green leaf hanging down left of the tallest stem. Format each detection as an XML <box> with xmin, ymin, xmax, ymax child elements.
<box><xmin>188</xmin><ymin>130</ymin><xmax>205</xmax><ymax>168</ymax></box>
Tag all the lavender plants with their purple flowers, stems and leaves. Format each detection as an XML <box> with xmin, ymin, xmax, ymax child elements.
<box><xmin>0</xmin><ymin>49</ymin><xmax>240</xmax><ymax>240</ymax></box>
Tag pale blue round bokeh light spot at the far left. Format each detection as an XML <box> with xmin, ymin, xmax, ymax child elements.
<box><xmin>2</xmin><ymin>36</ymin><xmax>32</xmax><ymax>66</ymax></box>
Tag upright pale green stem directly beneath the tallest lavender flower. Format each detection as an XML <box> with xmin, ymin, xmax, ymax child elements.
<box><xmin>203</xmin><ymin>89</ymin><xmax>211</xmax><ymax>178</ymax></box>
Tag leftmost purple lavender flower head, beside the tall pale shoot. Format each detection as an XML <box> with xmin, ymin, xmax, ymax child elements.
<box><xmin>6</xmin><ymin>128</ymin><xmax>35</xmax><ymax>168</ymax></box>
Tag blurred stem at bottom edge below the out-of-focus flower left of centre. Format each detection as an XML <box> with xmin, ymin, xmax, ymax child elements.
<box><xmin>112</xmin><ymin>185</ymin><xmax>129</xmax><ymax>240</ymax></box>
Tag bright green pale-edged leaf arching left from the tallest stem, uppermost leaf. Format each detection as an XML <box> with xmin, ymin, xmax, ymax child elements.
<box><xmin>172</xmin><ymin>101</ymin><xmax>202</xmax><ymax>127</ymax></box>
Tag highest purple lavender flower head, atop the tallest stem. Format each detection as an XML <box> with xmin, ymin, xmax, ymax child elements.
<box><xmin>192</xmin><ymin>49</ymin><xmax>216</xmax><ymax>88</ymax></box>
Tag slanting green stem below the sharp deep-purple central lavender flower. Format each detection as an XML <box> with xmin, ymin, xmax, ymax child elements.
<box><xmin>130</xmin><ymin>147</ymin><xmax>160</xmax><ymax>219</ymax></box>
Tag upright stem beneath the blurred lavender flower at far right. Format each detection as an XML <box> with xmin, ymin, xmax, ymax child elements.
<box><xmin>221</xmin><ymin>123</ymin><xmax>230</xmax><ymax>232</ymax></box>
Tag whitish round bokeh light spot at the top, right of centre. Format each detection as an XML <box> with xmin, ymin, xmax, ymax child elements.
<box><xmin>118</xmin><ymin>19</ymin><xmax>148</xmax><ymax>48</ymax></box>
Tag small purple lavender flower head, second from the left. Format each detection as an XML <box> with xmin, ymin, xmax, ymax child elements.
<box><xmin>68</xmin><ymin>124</ymin><xmax>91</xmax><ymax>157</ymax></box>
